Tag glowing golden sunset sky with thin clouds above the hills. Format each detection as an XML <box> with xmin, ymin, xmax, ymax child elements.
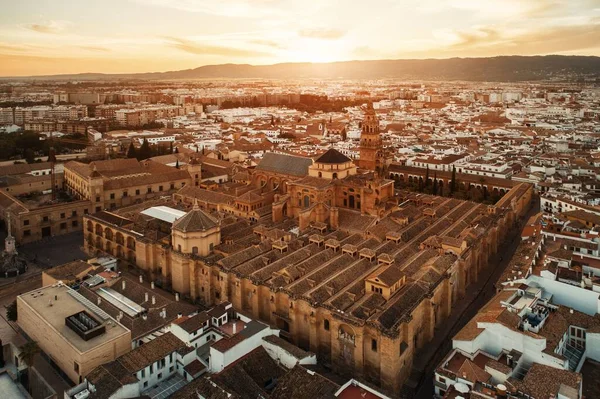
<box><xmin>0</xmin><ymin>0</ymin><xmax>600</xmax><ymax>76</ymax></box>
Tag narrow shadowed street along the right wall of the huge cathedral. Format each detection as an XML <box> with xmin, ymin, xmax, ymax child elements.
<box><xmin>405</xmin><ymin>202</ymin><xmax>539</xmax><ymax>399</ymax></box>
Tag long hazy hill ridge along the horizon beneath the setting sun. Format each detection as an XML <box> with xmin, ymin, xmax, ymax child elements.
<box><xmin>3</xmin><ymin>55</ymin><xmax>600</xmax><ymax>82</ymax></box>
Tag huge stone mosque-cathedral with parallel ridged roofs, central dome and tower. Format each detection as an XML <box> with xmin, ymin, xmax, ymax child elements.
<box><xmin>79</xmin><ymin>108</ymin><xmax>532</xmax><ymax>394</ymax></box>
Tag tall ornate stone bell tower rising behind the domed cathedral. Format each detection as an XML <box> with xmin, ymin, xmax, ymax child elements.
<box><xmin>358</xmin><ymin>103</ymin><xmax>385</xmax><ymax>174</ymax></box>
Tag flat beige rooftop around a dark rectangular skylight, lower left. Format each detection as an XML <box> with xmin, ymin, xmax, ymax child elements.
<box><xmin>19</xmin><ymin>285</ymin><xmax>131</xmax><ymax>353</ymax></box>
